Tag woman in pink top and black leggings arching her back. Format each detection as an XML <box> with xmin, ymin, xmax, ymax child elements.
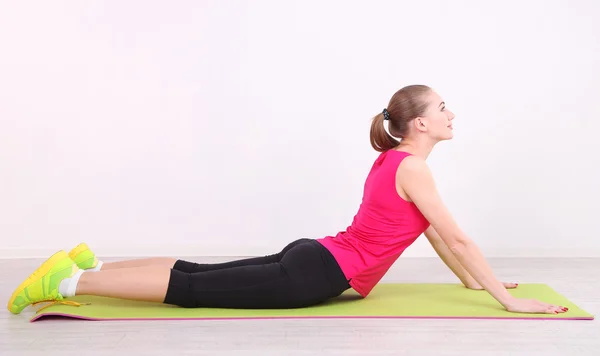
<box><xmin>8</xmin><ymin>85</ymin><xmax>567</xmax><ymax>314</ymax></box>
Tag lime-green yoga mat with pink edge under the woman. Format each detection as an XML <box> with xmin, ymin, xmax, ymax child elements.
<box><xmin>31</xmin><ymin>284</ymin><xmax>594</xmax><ymax>321</ymax></box>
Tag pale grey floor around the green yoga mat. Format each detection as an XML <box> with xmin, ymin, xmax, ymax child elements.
<box><xmin>0</xmin><ymin>258</ymin><xmax>600</xmax><ymax>356</ymax></box>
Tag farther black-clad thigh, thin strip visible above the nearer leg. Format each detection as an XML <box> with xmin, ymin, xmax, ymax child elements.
<box><xmin>173</xmin><ymin>239</ymin><xmax>310</xmax><ymax>273</ymax></box>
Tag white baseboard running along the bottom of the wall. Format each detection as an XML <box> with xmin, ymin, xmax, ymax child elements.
<box><xmin>0</xmin><ymin>245</ymin><xmax>600</xmax><ymax>259</ymax></box>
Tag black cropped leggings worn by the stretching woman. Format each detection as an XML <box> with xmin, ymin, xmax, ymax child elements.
<box><xmin>164</xmin><ymin>239</ymin><xmax>350</xmax><ymax>309</ymax></box>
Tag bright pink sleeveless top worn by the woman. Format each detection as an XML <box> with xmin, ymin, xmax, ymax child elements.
<box><xmin>317</xmin><ymin>150</ymin><xmax>429</xmax><ymax>297</ymax></box>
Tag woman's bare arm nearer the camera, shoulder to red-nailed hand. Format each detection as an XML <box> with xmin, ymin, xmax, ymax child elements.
<box><xmin>397</xmin><ymin>156</ymin><xmax>564</xmax><ymax>313</ymax></box>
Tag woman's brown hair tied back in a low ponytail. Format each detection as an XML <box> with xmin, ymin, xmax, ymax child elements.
<box><xmin>371</xmin><ymin>85</ymin><xmax>431</xmax><ymax>152</ymax></box>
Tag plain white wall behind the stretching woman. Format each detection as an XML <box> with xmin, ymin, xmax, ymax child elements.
<box><xmin>0</xmin><ymin>0</ymin><xmax>600</xmax><ymax>257</ymax></box>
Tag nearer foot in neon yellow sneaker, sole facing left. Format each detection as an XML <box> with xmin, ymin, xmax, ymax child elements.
<box><xmin>8</xmin><ymin>251</ymin><xmax>79</xmax><ymax>314</ymax></box>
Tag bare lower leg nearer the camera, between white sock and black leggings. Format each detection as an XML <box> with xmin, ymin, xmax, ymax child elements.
<box><xmin>75</xmin><ymin>265</ymin><xmax>171</xmax><ymax>303</ymax></box>
